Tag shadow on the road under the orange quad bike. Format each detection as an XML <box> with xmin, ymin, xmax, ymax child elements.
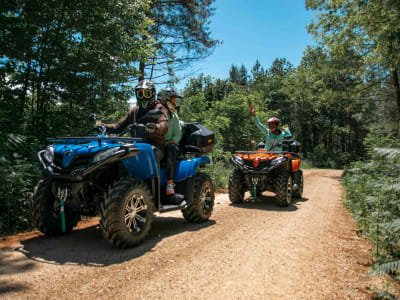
<box><xmin>231</xmin><ymin>195</ymin><xmax>308</xmax><ymax>211</ymax></box>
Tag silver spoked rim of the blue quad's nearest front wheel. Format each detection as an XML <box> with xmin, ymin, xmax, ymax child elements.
<box><xmin>124</xmin><ymin>193</ymin><xmax>147</xmax><ymax>233</ymax></box>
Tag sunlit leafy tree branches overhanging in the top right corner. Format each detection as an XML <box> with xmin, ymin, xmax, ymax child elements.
<box><xmin>306</xmin><ymin>0</ymin><xmax>400</xmax><ymax>122</ymax></box>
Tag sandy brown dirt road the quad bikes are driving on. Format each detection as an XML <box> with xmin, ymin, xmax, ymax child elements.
<box><xmin>0</xmin><ymin>170</ymin><xmax>398</xmax><ymax>299</ymax></box>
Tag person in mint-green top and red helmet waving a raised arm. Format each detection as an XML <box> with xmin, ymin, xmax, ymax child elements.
<box><xmin>250</xmin><ymin>105</ymin><xmax>292</xmax><ymax>152</ymax></box>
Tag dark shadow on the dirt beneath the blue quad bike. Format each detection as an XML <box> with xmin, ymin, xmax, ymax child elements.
<box><xmin>16</xmin><ymin>216</ymin><xmax>215</xmax><ymax>267</ymax></box>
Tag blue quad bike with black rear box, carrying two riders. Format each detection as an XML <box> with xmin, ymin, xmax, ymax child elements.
<box><xmin>33</xmin><ymin>110</ymin><xmax>215</xmax><ymax>248</ymax></box>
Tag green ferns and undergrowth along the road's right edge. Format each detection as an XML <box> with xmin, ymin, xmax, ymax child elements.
<box><xmin>343</xmin><ymin>130</ymin><xmax>400</xmax><ymax>273</ymax></box>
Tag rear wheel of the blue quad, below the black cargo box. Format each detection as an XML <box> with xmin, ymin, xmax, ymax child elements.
<box><xmin>182</xmin><ymin>173</ymin><xmax>214</xmax><ymax>222</ymax></box>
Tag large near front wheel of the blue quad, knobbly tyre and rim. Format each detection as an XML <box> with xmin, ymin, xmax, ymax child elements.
<box><xmin>100</xmin><ymin>178</ymin><xmax>153</xmax><ymax>248</ymax></box>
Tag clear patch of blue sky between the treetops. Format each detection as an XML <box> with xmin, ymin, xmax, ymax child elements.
<box><xmin>177</xmin><ymin>0</ymin><xmax>313</xmax><ymax>89</ymax></box>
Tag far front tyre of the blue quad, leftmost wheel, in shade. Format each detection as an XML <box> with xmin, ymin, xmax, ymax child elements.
<box><xmin>32</xmin><ymin>180</ymin><xmax>80</xmax><ymax>236</ymax></box>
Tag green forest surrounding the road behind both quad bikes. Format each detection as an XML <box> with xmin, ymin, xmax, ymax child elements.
<box><xmin>0</xmin><ymin>0</ymin><xmax>400</xmax><ymax>275</ymax></box>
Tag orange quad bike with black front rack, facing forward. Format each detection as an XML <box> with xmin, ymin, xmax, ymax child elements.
<box><xmin>229</xmin><ymin>140</ymin><xmax>303</xmax><ymax>206</ymax></box>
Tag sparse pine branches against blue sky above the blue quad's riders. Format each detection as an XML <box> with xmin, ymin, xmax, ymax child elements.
<box><xmin>139</xmin><ymin>0</ymin><xmax>219</xmax><ymax>83</ymax></box>
